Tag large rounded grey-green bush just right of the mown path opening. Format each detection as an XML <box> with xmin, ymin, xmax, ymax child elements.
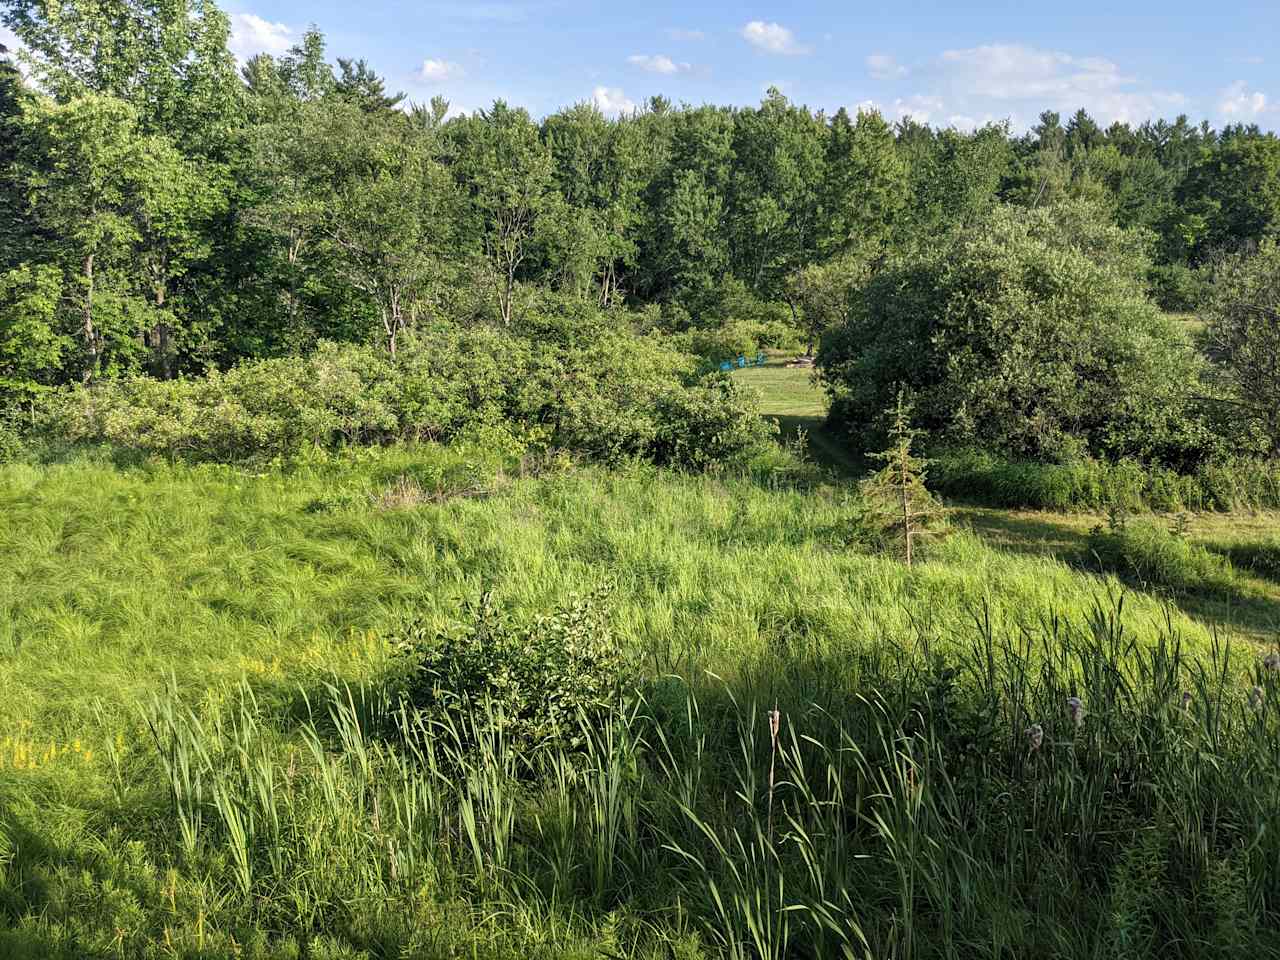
<box><xmin>819</xmin><ymin>204</ymin><xmax>1204</xmax><ymax>461</ymax></box>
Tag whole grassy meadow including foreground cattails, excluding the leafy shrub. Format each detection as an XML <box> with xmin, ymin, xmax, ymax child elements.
<box><xmin>0</xmin><ymin>448</ymin><xmax>1280</xmax><ymax>960</ymax></box>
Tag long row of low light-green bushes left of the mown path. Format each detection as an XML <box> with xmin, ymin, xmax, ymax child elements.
<box><xmin>45</xmin><ymin>311</ymin><xmax>771</xmax><ymax>467</ymax></box>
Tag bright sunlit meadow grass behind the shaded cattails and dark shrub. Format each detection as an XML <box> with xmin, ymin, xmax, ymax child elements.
<box><xmin>0</xmin><ymin>451</ymin><xmax>1223</xmax><ymax>747</ymax></box>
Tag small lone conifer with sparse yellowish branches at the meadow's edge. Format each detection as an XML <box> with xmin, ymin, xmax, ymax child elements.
<box><xmin>863</xmin><ymin>390</ymin><xmax>940</xmax><ymax>567</ymax></box>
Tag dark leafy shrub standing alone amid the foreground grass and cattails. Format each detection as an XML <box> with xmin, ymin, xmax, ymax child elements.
<box><xmin>386</xmin><ymin>594</ymin><xmax>636</xmax><ymax>753</ymax></box>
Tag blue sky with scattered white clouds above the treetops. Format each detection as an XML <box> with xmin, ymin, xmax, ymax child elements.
<box><xmin>40</xmin><ymin>0</ymin><xmax>1280</xmax><ymax>129</ymax></box>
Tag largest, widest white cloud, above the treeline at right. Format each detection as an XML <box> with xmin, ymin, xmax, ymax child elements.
<box><xmin>933</xmin><ymin>44</ymin><xmax>1188</xmax><ymax>124</ymax></box>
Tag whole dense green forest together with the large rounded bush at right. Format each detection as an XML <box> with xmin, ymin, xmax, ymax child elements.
<box><xmin>0</xmin><ymin>0</ymin><xmax>1280</xmax><ymax>466</ymax></box>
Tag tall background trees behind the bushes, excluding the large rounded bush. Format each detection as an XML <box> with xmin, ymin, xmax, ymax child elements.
<box><xmin>0</xmin><ymin>0</ymin><xmax>1280</xmax><ymax>402</ymax></box>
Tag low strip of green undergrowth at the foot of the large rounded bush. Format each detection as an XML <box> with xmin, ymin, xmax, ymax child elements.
<box><xmin>929</xmin><ymin>449</ymin><xmax>1280</xmax><ymax>511</ymax></box>
